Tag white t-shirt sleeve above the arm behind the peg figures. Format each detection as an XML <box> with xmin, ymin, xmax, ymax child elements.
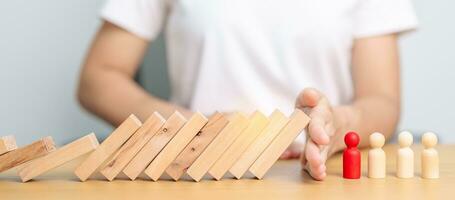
<box><xmin>354</xmin><ymin>0</ymin><xmax>418</xmax><ymax>38</ymax></box>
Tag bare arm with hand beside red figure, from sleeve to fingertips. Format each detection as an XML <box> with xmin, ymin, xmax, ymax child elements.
<box><xmin>296</xmin><ymin>34</ymin><xmax>400</xmax><ymax>180</ymax></box>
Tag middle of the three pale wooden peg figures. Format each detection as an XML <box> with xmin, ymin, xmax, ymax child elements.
<box><xmin>397</xmin><ymin>131</ymin><xmax>414</xmax><ymax>178</ymax></box>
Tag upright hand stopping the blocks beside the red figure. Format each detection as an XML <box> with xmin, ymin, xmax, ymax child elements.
<box><xmin>296</xmin><ymin>89</ymin><xmax>343</xmax><ymax>180</ymax></box>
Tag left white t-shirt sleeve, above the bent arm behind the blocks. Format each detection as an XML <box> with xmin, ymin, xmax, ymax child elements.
<box><xmin>101</xmin><ymin>0</ymin><xmax>167</xmax><ymax>40</ymax></box>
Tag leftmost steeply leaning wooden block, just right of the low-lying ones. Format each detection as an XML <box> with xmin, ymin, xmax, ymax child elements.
<box><xmin>74</xmin><ymin>115</ymin><xmax>142</xmax><ymax>181</ymax></box>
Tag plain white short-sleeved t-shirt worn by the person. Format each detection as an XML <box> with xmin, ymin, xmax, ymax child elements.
<box><xmin>102</xmin><ymin>0</ymin><xmax>417</xmax><ymax>145</ymax></box>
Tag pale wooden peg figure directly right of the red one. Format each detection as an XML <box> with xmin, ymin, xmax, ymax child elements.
<box><xmin>368</xmin><ymin>132</ymin><xmax>386</xmax><ymax>178</ymax></box>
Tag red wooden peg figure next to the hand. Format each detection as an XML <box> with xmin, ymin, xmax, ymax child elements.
<box><xmin>343</xmin><ymin>131</ymin><xmax>360</xmax><ymax>179</ymax></box>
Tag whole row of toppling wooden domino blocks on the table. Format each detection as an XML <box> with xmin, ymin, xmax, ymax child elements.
<box><xmin>0</xmin><ymin>110</ymin><xmax>310</xmax><ymax>182</ymax></box>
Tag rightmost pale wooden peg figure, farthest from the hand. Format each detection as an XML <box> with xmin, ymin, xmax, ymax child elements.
<box><xmin>421</xmin><ymin>132</ymin><xmax>439</xmax><ymax>179</ymax></box>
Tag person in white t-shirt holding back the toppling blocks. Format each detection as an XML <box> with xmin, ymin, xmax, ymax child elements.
<box><xmin>78</xmin><ymin>0</ymin><xmax>417</xmax><ymax>180</ymax></box>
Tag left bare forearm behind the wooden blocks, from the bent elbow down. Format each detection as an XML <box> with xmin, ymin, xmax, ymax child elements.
<box><xmin>78</xmin><ymin>68</ymin><xmax>190</xmax><ymax>126</ymax></box>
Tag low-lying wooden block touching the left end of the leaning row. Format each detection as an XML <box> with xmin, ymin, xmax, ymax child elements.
<box><xmin>18</xmin><ymin>133</ymin><xmax>99</xmax><ymax>182</ymax></box>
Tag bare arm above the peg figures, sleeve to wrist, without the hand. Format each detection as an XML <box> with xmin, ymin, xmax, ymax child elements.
<box><xmin>334</xmin><ymin>34</ymin><xmax>400</xmax><ymax>150</ymax></box>
